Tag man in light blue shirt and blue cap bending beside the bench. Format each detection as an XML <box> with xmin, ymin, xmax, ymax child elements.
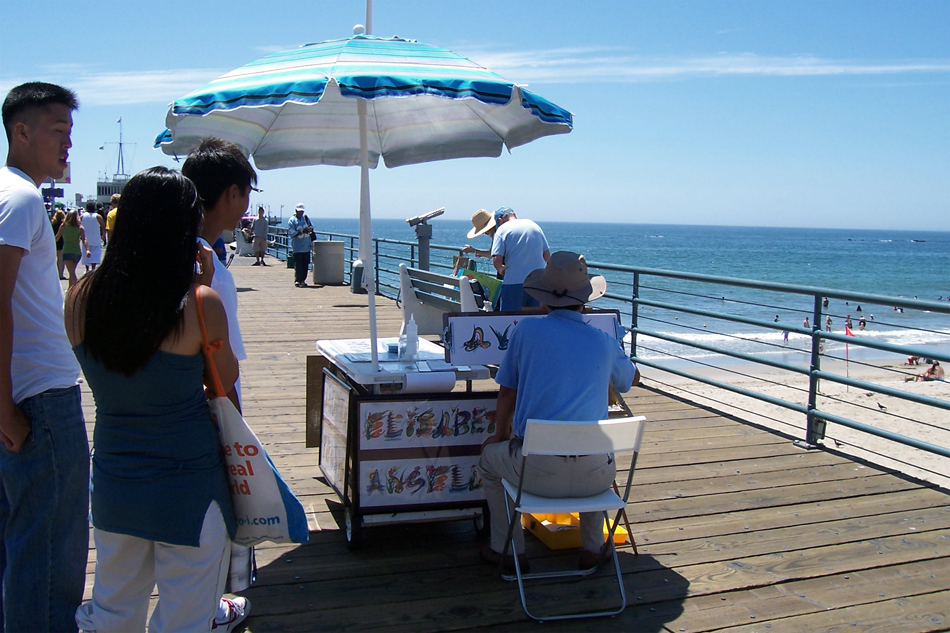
<box><xmin>491</xmin><ymin>207</ymin><xmax>551</xmax><ymax>311</ymax></box>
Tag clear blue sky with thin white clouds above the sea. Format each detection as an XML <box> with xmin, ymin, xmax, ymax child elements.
<box><xmin>0</xmin><ymin>0</ymin><xmax>950</xmax><ymax>230</ymax></box>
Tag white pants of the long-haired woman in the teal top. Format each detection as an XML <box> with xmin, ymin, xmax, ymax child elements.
<box><xmin>76</xmin><ymin>501</ymin><xmax>231</xmax><ymax>633</ymax></box>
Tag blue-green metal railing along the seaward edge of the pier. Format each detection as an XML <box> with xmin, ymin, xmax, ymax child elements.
<box><xmin>271</xmin><ymin>229</ymin><xmax>950</xmax><ymax>476</ymax></box>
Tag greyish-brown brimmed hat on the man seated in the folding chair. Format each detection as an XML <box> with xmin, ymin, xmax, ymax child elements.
<box><xmin>524</xmin><ymin>251</ymin><xmax>607</xmax><ymax>307</ymax></box>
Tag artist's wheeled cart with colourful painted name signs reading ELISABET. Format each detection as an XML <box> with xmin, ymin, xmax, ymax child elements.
<box><xmin>307</xmin><ymin>310</ymin><xmax>629</xmax><ymax>548</ymax></box>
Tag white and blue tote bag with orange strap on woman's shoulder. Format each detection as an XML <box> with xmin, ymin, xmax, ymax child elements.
<box><xmin>195</xmin><ymin>292</ymin><xmax>310</xmax><ymax>547</ymax></box>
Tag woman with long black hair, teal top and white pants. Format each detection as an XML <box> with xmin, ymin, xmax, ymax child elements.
<box><xmin>66</xmin><ymin>167</ymin><xmax>249</xmax><ymax>632</ymax></box>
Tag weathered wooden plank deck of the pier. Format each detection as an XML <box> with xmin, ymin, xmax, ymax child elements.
<box><xmin>83</xmin><ymin>258</ymin><xmax>950</xmax><ymax>633</ymax></box>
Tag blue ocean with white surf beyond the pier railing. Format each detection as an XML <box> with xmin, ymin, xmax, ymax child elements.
<box><xmin>302</xmin><ymin>218</ymin><xmax>950</xmax><ymax>362</ymax></box>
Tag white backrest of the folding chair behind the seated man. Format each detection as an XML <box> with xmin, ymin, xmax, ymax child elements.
<box><xmin>521</xmin><ymin>415</ymin><xmax>646</xmax><ymax>455</ymax></box>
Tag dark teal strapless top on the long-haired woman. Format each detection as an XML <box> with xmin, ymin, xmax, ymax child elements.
<box><xmin>73</xmin><ymin>343</ymin><xmax>236</xmax><ymax>547</ymax></box>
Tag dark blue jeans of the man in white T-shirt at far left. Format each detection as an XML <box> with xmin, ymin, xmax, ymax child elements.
<box><xmin>0</xmin><ymin>386</ymin><xmax>89</xmax><ymax>633</ymax></box>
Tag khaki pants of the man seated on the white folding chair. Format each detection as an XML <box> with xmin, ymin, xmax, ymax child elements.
<box><xmin>478</xmin><ymin>438</ymin><xmax>617</xmax><ymax>554</ymax></box>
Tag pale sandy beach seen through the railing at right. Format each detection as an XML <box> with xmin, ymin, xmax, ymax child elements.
<box><xmin>641</xmin><ymin>360</ymin><xmax>950</xmax><ymax>489</ymax></box>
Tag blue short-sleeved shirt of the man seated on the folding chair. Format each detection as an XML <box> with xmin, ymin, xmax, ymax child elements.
<box><xmin>495</xmin><ymin>310</ymin><xmax>636</xmax><ymax>437</ymax></box>
